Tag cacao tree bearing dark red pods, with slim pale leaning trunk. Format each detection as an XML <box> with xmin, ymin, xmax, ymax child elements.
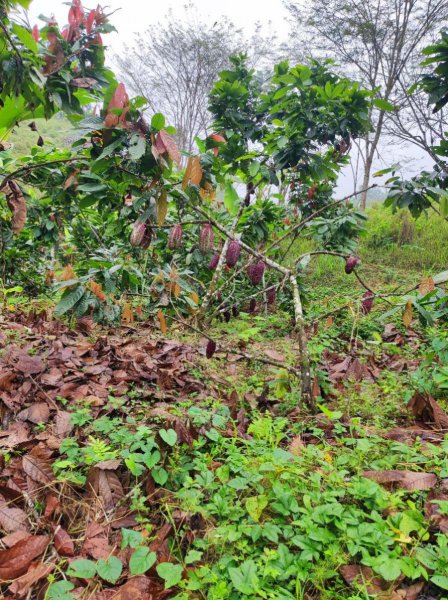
<box><xmin>0</xmin><ymin>0</ymin><xmax>373</xmax><ymax>407</ymax></box>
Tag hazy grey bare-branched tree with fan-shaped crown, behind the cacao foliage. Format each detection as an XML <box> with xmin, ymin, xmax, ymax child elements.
<box><xmin>115</xmin><ymin>4</ymin><xmax>273</xmax><ymax>151</ymax></box>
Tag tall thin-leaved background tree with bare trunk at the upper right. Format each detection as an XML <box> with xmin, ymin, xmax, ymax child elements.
<box><xmin>285</xmin><ymin>0</ymin><xmax>448</xmax><ymax>208</ymax></box>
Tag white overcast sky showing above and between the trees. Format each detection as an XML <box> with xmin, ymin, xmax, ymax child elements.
<box><xmin>29</xmin><ymin>0</ymin><xmax>432</xmax><ymax>195</ymax></box>
